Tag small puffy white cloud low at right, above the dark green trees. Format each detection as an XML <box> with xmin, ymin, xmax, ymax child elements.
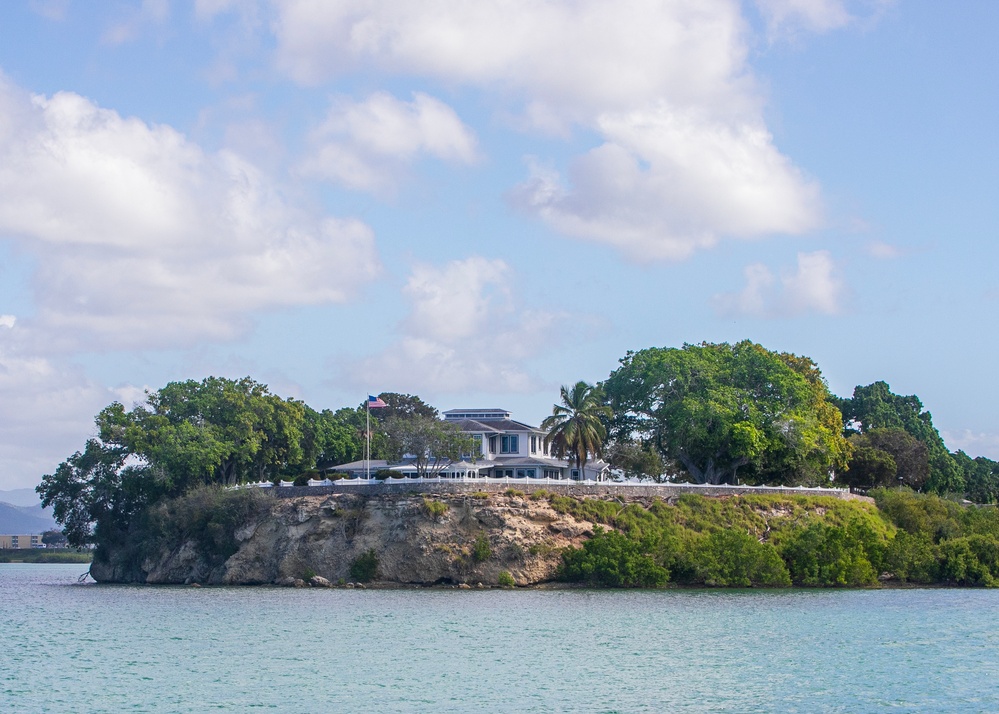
<box><xmin>712</xmin><ymin>250</ymin><xmax>844</xmax><ymax>318</ymax></box>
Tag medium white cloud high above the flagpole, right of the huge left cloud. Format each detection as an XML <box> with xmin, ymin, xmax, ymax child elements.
<box><xmin>300</xmin><ymin>92</ymin><xmax>478</xmax><ymax>191</ymax></box>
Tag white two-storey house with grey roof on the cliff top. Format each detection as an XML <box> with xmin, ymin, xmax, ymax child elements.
<box><xmin>333</xmin><ymin>409</ymin><xmax>608</xmax><ymax>481</ymax></box>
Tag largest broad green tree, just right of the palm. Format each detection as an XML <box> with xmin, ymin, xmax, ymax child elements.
<box><xmin>603</xmin><ymin>341</ymin><xmax>850</xmax><ymax>484</ymax></box>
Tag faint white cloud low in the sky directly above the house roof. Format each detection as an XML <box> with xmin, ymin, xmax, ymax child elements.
<box><xmin>348</xmin><ymin>257</ymin><xmax>565</xmax><ymax>395</ymax></box>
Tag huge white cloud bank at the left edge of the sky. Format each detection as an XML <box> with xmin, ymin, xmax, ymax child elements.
<box><xmin>0</xmin><ymin>75</ymin><xmax>379</xmax><ymax>349</ymax></box>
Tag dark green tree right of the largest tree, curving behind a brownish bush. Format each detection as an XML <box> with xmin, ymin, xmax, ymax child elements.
<box><xmin>838</xmin><ymin>381</ymin><xmax>964</xmax><ymax>493</ymax></box>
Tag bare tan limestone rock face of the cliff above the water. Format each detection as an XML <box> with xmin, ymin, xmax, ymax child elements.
<box><xmin>91</xmin><ymin>493</ymin><xmax>593</xmax><ymax>587</ymax></box>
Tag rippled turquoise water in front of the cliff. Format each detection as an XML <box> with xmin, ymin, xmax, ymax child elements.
<box><xmin>0</xmin><ymin>564</ymin><xmax>999</xmax><ymax>712</ymax></box>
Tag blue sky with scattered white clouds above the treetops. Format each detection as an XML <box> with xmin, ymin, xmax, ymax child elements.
<box><xmin>0</xmin><ymin>0</ymin><xmax>999</xmax><ymax>490</ymax></box>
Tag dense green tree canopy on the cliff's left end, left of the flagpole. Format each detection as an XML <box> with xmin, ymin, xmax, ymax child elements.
<box><xmin>37</xmin><ymin>377</ymin><xmax>370</xmax><ymax>546</ymax></box>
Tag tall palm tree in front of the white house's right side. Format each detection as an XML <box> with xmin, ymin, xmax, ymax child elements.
<box><xmin>541</xmin><ymin>381</ymin><xmax>612</xmax><ymax>478</ymax></box>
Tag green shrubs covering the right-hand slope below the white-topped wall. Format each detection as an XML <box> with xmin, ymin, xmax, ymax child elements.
<box><xmin>551</xmin><ymin>489</ymin><xmax>999</xmax><ymax>587</ymax></box>
